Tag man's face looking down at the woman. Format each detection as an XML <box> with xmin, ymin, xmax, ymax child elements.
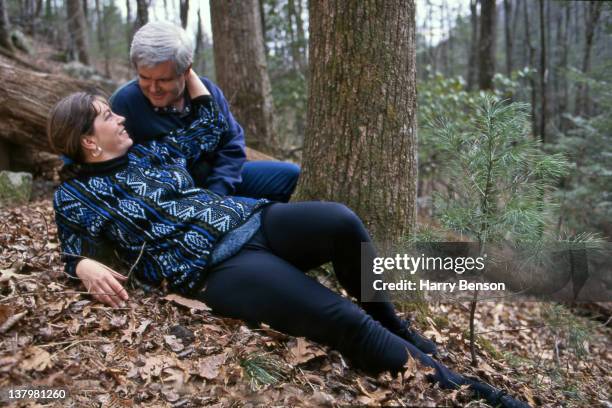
<box><xmin>137</xmin><ymin>61</ymin><xmax>189</xmax><ymax>108</ymax></box>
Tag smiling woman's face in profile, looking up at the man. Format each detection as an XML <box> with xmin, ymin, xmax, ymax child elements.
<box><xmin>84</xmin><ymin>100</ymin><xmax>134</xmax><ymax>161</ymax></box>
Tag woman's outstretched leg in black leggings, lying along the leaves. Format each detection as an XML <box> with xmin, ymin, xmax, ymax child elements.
<box><xmin>196</xmin><ymin>237</ymin><xmax>463</xmax><ymax>387</ymax></box>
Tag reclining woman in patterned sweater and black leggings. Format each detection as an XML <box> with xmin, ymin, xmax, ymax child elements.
<box><xmin>48</xmin><ymin>72</ymin><xmax>526</xmax><ymax>407</ymax></box>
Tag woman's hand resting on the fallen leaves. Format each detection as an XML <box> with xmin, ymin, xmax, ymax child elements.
<box><xmin>76</xmin><ymin>258</ymin><xmax>129</xmax><ymax>307</ymax></box>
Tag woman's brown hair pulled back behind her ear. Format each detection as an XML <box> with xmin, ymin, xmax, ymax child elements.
<box><xmin>47</xmin><ymin>92</ymin><xmax>106</xmax><ymax>163</ymax></box>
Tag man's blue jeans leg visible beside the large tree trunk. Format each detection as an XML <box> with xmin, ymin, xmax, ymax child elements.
<box><xmin>234</xmin><ymin>161</ymin><xmax>300</xmax><ymax>203</ymax></box>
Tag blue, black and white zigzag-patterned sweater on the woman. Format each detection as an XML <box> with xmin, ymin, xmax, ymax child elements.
<box><xmin>53</xmin><ymin>97</ymin><xmax>268</xmax><ymax>294</ymax></box>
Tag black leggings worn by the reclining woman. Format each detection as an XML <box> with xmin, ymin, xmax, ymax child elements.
<box><xmin>197</xmin><ymin>202</ymin><xmax>468</xmax><ymax>388</ymax></box>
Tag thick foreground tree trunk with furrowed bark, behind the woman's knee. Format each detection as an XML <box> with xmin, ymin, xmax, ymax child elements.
<box><xmin>298</xmin><ymin>0</ymin><xmax>417</xmax><ymax>242</ymax></box>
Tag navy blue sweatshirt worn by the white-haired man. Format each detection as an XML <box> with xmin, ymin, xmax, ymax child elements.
<box><xmin>110</xmin><ymin>77</ymin><xmax>246</xmax><ymax>196</ymax></box>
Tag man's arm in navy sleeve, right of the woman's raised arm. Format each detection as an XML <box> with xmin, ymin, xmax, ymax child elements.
<box><xmin>201</xmin><ymin>77</ymin><xmax>246</xmax><ymax>196</ymax></box>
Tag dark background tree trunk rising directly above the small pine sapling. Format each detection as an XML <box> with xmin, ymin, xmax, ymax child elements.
<box><xmin>478</xmin><ymin>0</ymin><xmax>497</xmax><ymax>89</ymax></box>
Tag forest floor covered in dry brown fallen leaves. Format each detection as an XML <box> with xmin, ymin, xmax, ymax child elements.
<box><xmin>0</xmin><ymin>183</ymin><xmax>612</xmax><ymax>407</ymax></box>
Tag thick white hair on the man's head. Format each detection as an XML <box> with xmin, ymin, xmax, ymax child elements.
<box><xmin>130</xmin><ymin>21</ymin><xmax>193</xmax><ymax>74</ymax></box>
